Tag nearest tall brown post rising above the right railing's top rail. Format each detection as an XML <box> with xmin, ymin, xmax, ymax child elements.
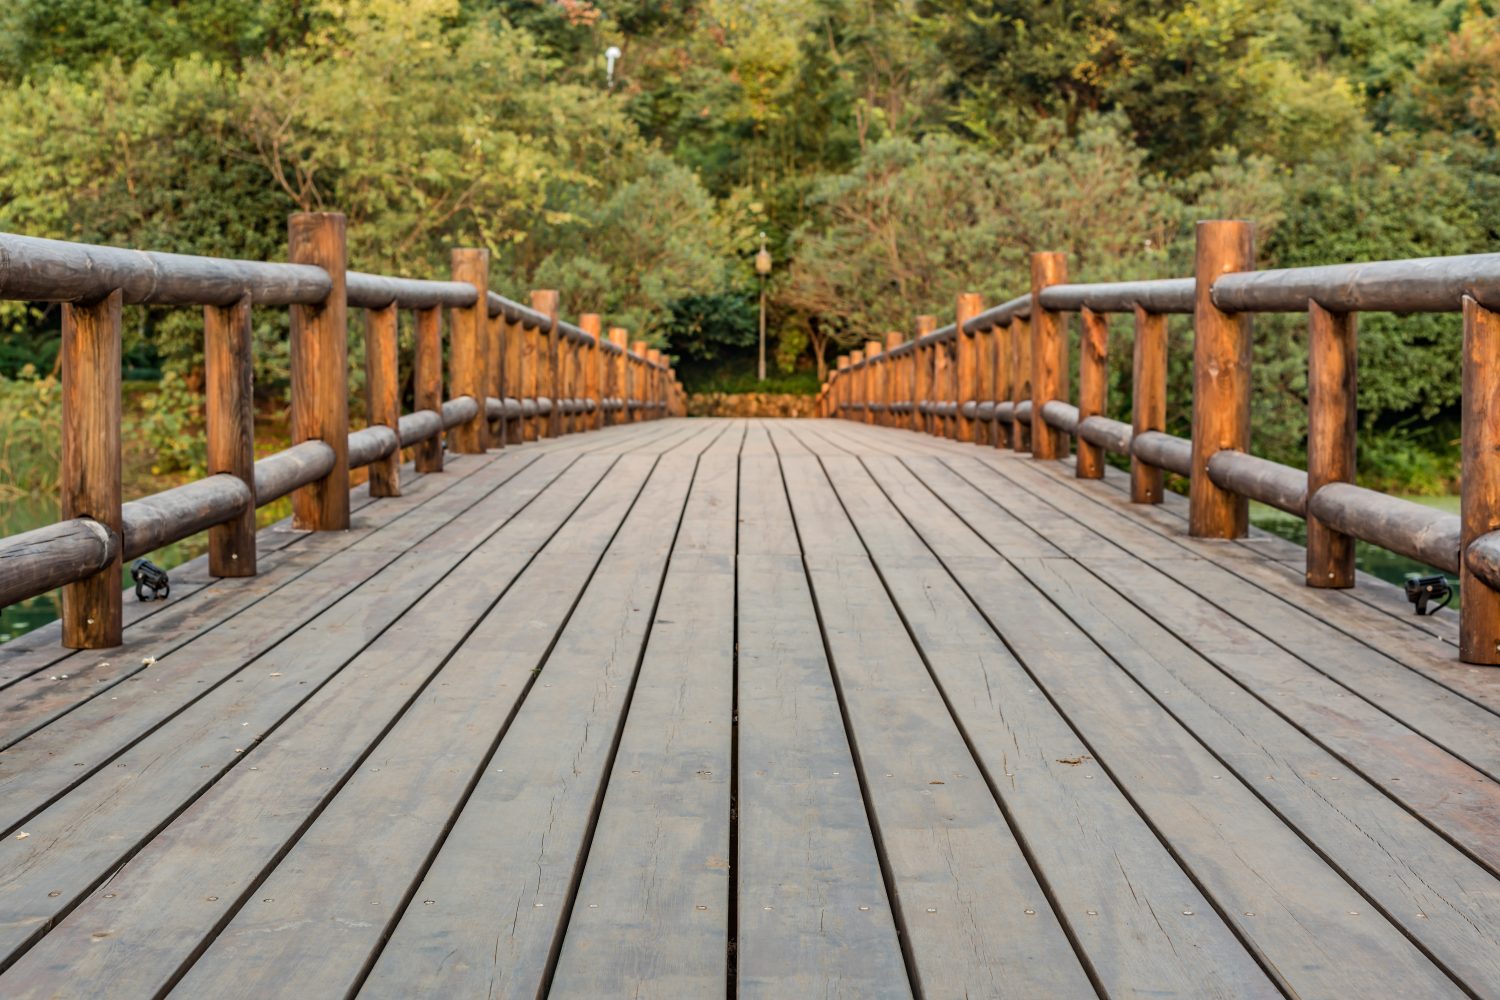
<box><xmin>1188</xmin><ymin>220</ymin><xmax>1256</xmax><ymax>538</ymax></box>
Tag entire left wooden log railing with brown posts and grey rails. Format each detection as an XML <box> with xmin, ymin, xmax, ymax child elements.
<box><xmin>0</xmin><ymin>213</ymin><xmax>684</xmax><ymax>649</ymax></box>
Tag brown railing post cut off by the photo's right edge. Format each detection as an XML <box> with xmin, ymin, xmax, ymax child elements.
<box><xmin>1458</xmin><ymin>295</ymin><xmax>1500</xmax><ymax>664</ymax></box>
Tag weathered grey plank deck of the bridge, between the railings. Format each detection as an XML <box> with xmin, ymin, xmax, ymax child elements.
<box><xmin>0</xmin><ymin>420</ymin><xmax>1500</xmax><ymax>1000</ymax></box>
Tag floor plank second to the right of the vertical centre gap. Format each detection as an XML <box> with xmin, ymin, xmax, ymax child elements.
<box><xmin>773</xmin><ymin>427</ymin><xmax>1094</xmax><ymax>997</ymax></box>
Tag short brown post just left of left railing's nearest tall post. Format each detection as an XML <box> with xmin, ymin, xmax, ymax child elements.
<box><xmin>203</xmin><ymin>295</ymin><xmax>255</xmax><ymax>577</ymax></box>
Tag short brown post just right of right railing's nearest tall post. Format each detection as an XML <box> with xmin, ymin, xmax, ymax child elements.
<box><xmin>1307</xmin><ymin>303</ymin><xmax>1358</xmax><ymax>586</ymax></box>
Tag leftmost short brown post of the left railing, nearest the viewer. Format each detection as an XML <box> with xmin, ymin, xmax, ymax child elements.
<box><xmin>59</xmin><ymin>291</ymin><xmax>125</xmax><ymax>649</ymax></box>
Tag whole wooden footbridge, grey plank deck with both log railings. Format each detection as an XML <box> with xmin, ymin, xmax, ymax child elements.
<box><xmin>0</xmin><ymin>216</ymin><xmax>1500</xmax><ymax>999</ymax></box>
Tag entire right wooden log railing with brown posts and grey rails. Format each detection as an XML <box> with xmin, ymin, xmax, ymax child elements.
<box><xmin>819</xmin><ymin>222</ymin><xmax>1500</xmax><ymax>664</ymax></box>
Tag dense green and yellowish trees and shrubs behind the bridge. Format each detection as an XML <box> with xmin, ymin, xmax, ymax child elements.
<box><xmin>0</xmin><ymin>0</ymin><xmax>1500</xmax><ymax>495</ymax></box>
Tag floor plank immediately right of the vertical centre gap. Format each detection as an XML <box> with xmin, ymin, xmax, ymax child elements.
<box><xmin>735</xmin><ymin>426</ymin><xmax>909</xmax><ymax>999</ymax></box>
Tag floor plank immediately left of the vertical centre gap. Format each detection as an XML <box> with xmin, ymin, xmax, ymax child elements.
<box><xmin>549</xmin><ymin>425</ymin><xmax>740</xmax><ymax>997</ymax></box>
